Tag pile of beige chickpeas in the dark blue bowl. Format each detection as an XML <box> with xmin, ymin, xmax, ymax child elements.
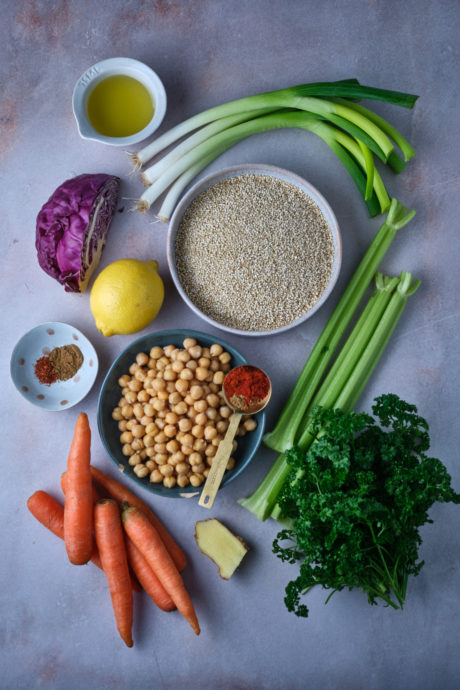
<box><xmin>112</xmin><ymin>338</ymin><xmax>257</xmax><ymax>488</ymax></box>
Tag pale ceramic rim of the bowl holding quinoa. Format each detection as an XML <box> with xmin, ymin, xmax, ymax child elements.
<box><xmin>166</xmin><ymin>163</ymin><xmax>342</xmax><ymax>337</ymax></box>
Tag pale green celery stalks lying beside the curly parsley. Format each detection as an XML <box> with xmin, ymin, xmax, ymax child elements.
<box><xmin>238</xmin><ymin>199</ymin><xmax>420</xmax><ymax>523</ymax></box>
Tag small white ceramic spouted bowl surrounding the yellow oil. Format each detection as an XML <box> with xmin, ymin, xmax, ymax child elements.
<box><xmin>72</xmin><ymin>57</ymin><xmax>166</xmax><ymax>146</ymax></box>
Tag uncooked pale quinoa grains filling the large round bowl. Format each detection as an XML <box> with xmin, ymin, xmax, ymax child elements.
<box><xmin>175</xmin><ymin>174</ymin><xmax>333</xmax><ymax>331</ymax></box>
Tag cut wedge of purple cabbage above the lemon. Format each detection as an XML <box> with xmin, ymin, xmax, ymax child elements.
<box><xmin>35</xmin><ymin>173</ymin><xmax>120</xmax><ymax>292</ymax></box>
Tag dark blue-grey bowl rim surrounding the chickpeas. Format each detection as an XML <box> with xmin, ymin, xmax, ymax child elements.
<box><xmin>97</xmin><ymin>328</ymin><xmax>266</xmax><ymax>498</ymax></box>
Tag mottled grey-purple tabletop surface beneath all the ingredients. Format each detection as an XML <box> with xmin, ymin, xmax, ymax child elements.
<box><xmin>0</xmin><ymin>0</ymin><xmax>460</xmax><ymax>690</ymax></box>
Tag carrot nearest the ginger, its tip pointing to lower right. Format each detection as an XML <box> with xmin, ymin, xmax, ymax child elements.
<box><xmin>122</xmin><ymin>506</ymin><xmax>200</xmax><ymax>635</ymax></box>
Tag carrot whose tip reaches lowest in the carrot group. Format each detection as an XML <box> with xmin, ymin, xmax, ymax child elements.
<box><xmin>94</xmin><ymin>498</ymin><xmax>133</xmax><ymax>647</ymax></box>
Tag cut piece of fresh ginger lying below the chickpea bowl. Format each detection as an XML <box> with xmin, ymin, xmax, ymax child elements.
<box><xmin>195</xmin><ymin>518</ymin><xmax>249</xmax><ymax>580</ymax></box>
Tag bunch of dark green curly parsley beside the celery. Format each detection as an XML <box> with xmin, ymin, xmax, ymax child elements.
<box><xmin>273</xmin><ymin>394</ymin><xmax>460</xmax><ymax>617</ymax></box>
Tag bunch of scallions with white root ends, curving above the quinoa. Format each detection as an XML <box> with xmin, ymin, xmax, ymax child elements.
<box><xmin>130</xmin><ymin>79</ymin><xmax>417</xmax><ymax>222</ymax></box>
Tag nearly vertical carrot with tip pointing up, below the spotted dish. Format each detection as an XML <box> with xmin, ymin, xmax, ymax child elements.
<box><xmin>64</xmin><ymin>412</ymin><xmax>93</xmax><ymax>565</ymax></box>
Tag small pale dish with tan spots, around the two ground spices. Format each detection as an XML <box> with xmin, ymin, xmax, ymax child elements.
<box><xmin>10</xmin><ymin>321</ymin><xmax>98</xmax><ymax>411</ymax></box>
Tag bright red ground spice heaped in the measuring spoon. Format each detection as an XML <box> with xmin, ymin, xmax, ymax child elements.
<box><xmin>223</xmin><ymin>364</ymin><xmax>270</xmax><ymax>410</ymax></box>
